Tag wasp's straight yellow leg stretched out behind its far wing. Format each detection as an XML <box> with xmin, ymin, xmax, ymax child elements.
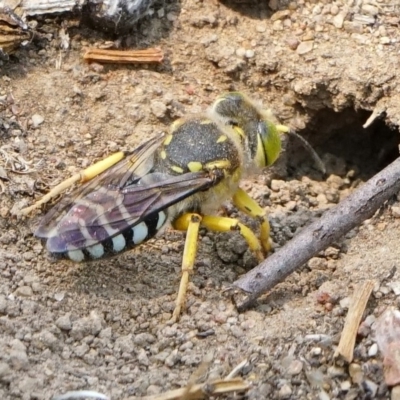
<box><xmin>19</xmin><ymin>151</ymin><xmax>125</xmax><ymax>215</ymax></box>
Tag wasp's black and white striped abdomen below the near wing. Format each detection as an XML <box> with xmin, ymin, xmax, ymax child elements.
<box><xmin>52</xmin><ymin>211</ymin><xmax>167</xmax><ymax>262</ymax></box>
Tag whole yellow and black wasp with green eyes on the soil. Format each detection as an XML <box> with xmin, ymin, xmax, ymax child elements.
<box><xmin>20</xmin><ymin>92</ymin><xmax>289</xmax><ymax>320</ymax></box>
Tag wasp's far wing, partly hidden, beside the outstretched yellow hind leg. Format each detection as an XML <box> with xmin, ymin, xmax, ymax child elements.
<box><xmin>35</xmin><ymin>136</ymin><xmax>164</xmax><ymax>238</ymax></box>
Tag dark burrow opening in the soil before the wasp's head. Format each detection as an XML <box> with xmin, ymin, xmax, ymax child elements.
<box><xmin>286</xmin><ymin>108</ymin><xmax>400</xmax><ymax>181</ymax></box>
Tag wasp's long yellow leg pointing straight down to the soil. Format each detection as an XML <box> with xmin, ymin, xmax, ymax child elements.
<box><xmin>172</xmin><ymin>213</ymin><xmax>202</xmax><ymax>321</ymax></box>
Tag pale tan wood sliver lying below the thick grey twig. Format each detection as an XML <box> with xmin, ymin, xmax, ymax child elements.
<box><xmin>334</xmin><ymin>281</ymin><xmax>375</xmax><ymax>363</ymax></box>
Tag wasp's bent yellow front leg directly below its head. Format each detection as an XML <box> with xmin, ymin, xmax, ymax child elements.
<box><xmin>233</xmin><ymin>188</ymin><xmax>272</xmax><ymax>253</ymax></box>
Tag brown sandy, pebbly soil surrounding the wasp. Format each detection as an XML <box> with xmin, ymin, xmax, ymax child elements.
<box><xmin>0</xmin><ymin>0</ymin><xmax>400</xmax><ymax>400</ymax></box>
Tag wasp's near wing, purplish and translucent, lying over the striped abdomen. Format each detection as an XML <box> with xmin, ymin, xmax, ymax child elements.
<box><xmin>40</xmin><ymin>172</ymin><xmax>219</xmax><ymax>253</ymax></box>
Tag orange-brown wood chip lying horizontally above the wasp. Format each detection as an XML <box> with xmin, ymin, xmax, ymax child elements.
<box><xmin>83</xmin><ymin>48</ymin><xmax>164</xmax><ymax>64</ymax></box>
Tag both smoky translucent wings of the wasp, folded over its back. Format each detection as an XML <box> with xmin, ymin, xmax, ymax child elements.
<box><xmin>35</xmin><ymin>135</ymin><xmax>222</xmax><ymax>253</ymax></box>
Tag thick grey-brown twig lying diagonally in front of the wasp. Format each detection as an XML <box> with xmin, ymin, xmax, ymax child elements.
<box><xmin>234</xmin><ymin>158</ymin><xmax>400</xmax><ymax>311</ymax></box>
